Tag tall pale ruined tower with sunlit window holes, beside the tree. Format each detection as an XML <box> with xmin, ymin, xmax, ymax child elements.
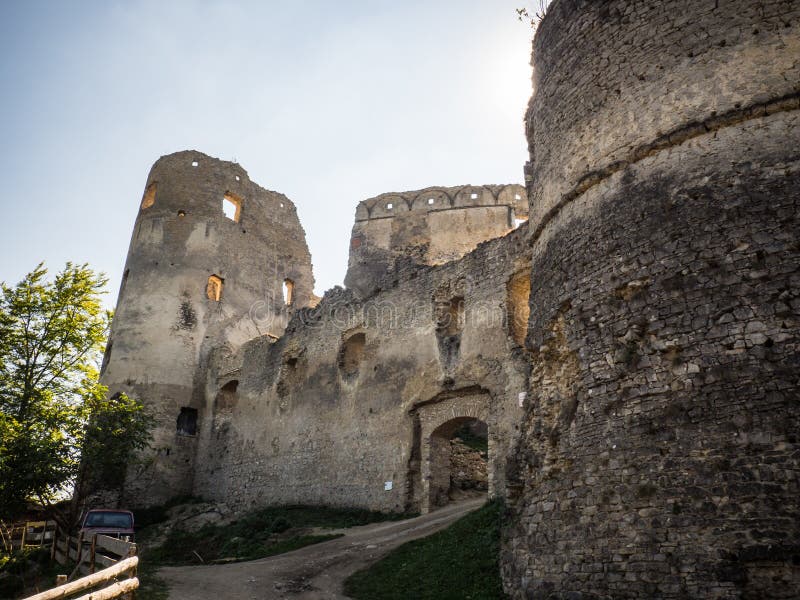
<box><xmin>101</xmin><ymin>151</ymin><xmax>314</xmax><ymax>505</ymax></box>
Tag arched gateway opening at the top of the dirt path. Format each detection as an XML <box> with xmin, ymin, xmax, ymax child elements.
<box><xmin>428</xmin><ymin>417</ymin><xmax>489</xmax><ymax>510</ymax></box>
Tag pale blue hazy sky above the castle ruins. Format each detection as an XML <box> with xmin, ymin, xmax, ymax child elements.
<box><xmin>0</xmin><ymin>0</ymin><xmax>532</xmax><ymax>305</ymax></box>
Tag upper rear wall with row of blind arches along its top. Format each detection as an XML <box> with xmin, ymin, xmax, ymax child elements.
<box><xmin>345</xmin><ymin>185</ymin><xmax>528</xmax><ymax>297</ymax></box>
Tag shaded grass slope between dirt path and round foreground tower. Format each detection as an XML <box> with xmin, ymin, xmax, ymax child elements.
<box><xmin>344</xmin><ymin>502</ymin><xmax>506</xmax><ymax>600</ymax></box>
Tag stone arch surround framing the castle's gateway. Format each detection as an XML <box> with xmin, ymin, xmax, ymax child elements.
<box><xmin>415</xmin><ymin>392</ymin><xmax>494</xmax><ymax>514</ymax></box>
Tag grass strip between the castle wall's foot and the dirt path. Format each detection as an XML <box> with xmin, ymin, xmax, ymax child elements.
<box><xmin>143</xmin><ymin>506</ymin><xmax>409</xmax><ymax>566</ymax></box>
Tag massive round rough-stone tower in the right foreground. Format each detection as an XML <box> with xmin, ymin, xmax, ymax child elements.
<box><xmin>503</xmin><ymin>0</ymin><xmax>800</xmax><ymax>599</ymax></box>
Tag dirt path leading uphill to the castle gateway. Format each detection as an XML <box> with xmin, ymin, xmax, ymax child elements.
<box><xmin>159</xmin><ymin>498</ymin><xmax>485</xmax><ymax>600</ymax></box>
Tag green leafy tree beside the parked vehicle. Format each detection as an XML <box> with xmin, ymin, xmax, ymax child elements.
<box><xmin>0</xmin><ymin>263</ymin><xmax>149</xmax><ymax>518</ymax></box>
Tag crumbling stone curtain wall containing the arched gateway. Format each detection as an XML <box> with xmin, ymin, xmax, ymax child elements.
<box><xmin>194</xmin><ymin>230</ymin><xmax>529</xmax><ymax>510</ymax></box>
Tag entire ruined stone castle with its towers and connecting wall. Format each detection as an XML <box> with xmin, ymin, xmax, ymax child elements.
<box><xmin>102</xmin><ymin>0</ymin><xmax>800</xmax><ymax>599</ymax></box>
